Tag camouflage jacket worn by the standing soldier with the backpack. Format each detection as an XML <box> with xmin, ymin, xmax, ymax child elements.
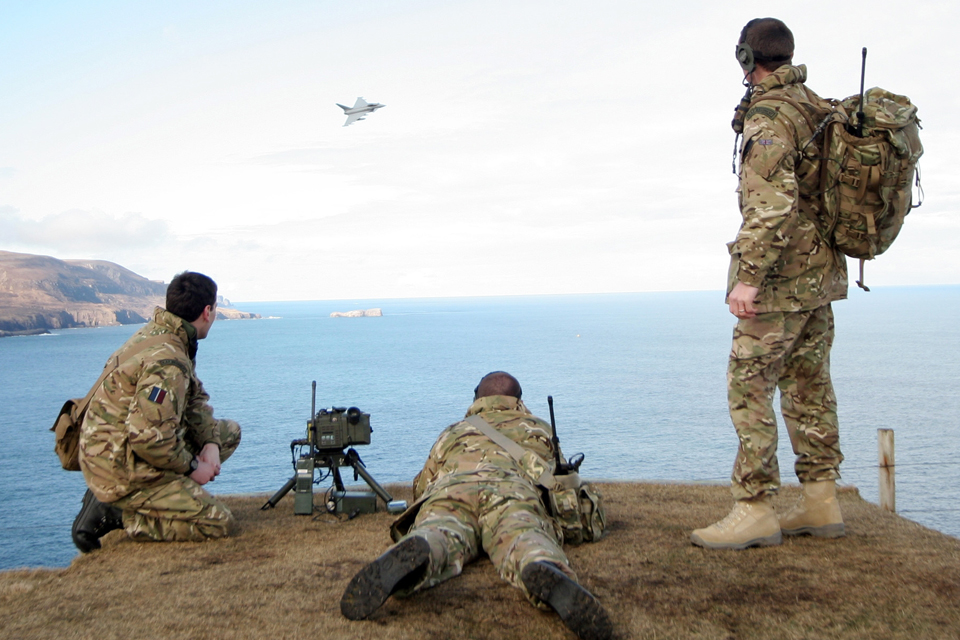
<box><xmin>727</xmin><ymin>65</ymin><xmax>847</xmax><ymax>313</ymax></box>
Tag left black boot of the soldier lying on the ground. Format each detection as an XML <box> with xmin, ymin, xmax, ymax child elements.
<box><xmin>340</xmin><ymin>536</ymin><xmax>430</xmax><ymax>620</ymax></box>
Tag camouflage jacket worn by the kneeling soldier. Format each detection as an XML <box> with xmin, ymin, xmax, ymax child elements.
<box><xmin>80</xmin><ymin>307</ymin><xmax>220</xmax><ymax>502</ymax></box>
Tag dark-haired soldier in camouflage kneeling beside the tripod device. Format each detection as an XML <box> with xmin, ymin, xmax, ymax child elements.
<box><xmin>72</xmin><ymin>272</ymin><xmax>240</xmax><ymax>553</ymax></box>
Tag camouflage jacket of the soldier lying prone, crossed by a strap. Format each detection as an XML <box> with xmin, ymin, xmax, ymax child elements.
<box><xmin>413</xmin><ymin>396</ymin><xmax>554</xmax><ymax>499</ymax></box>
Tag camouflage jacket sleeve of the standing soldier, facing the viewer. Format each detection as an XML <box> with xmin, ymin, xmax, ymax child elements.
<box><xmin>733</xmin><ymin>115</ymin><xmax>798</xmax><ymax>287</ymax></box>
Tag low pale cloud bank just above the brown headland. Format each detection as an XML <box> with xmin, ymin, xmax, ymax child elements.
<box><xmin>0</xmin><ymin>206</ymin><xmax>171</xmax><ymax>256</ymax></box>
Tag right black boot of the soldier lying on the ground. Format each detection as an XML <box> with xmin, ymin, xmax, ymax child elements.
<box><xmin>520</xmin><ymin>561</ymin><xmax>613</xmax><ymax>640</ymax></box>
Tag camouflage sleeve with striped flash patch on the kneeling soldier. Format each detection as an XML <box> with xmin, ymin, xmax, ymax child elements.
<box><xmin>127</xmin><ymin>360</ymin><xmax>193</xmax><ymax>472</ymax></box>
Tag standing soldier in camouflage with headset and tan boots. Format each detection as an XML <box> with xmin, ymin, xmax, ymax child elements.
<box><xmin>692</xmin><ymin>18</ymin><xmax>847</xmax><ymax>549</ymax></box>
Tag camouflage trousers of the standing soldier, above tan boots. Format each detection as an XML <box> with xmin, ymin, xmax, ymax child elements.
<box><xmin>727</xmin><ymin>304</ymin><xmax>843</xmax><ymax>500</ymax></box>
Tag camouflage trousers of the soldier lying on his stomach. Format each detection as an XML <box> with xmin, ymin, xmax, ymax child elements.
<box><xmin>401</xmin><ymin>479</ymin><xmax>577</xmax><ymax>605</ymax></box>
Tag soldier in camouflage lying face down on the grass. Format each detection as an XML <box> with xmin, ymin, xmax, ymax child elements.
<box><xmin>340</xmin><ymin>371</ymin><xmax>612</xmax><ymax>638</ymax></box>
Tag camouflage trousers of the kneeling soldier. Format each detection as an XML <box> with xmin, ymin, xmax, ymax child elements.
<box><xmin>112</xmin><ymin>420</ymin><xmax>240</xmax><ymax>542</ymax></box>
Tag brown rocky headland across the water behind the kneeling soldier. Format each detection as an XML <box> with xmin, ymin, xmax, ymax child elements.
<box><xmin>0</xmin><ymin>251</ymin><xmax>255</xmax><ymax>336</ymax></box>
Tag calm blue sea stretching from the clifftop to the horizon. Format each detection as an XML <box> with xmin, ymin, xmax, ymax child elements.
<box><xmin>0</xmin><ymin>286</ymin><xmax>960</xmax><ymax>569</ymax></box>
